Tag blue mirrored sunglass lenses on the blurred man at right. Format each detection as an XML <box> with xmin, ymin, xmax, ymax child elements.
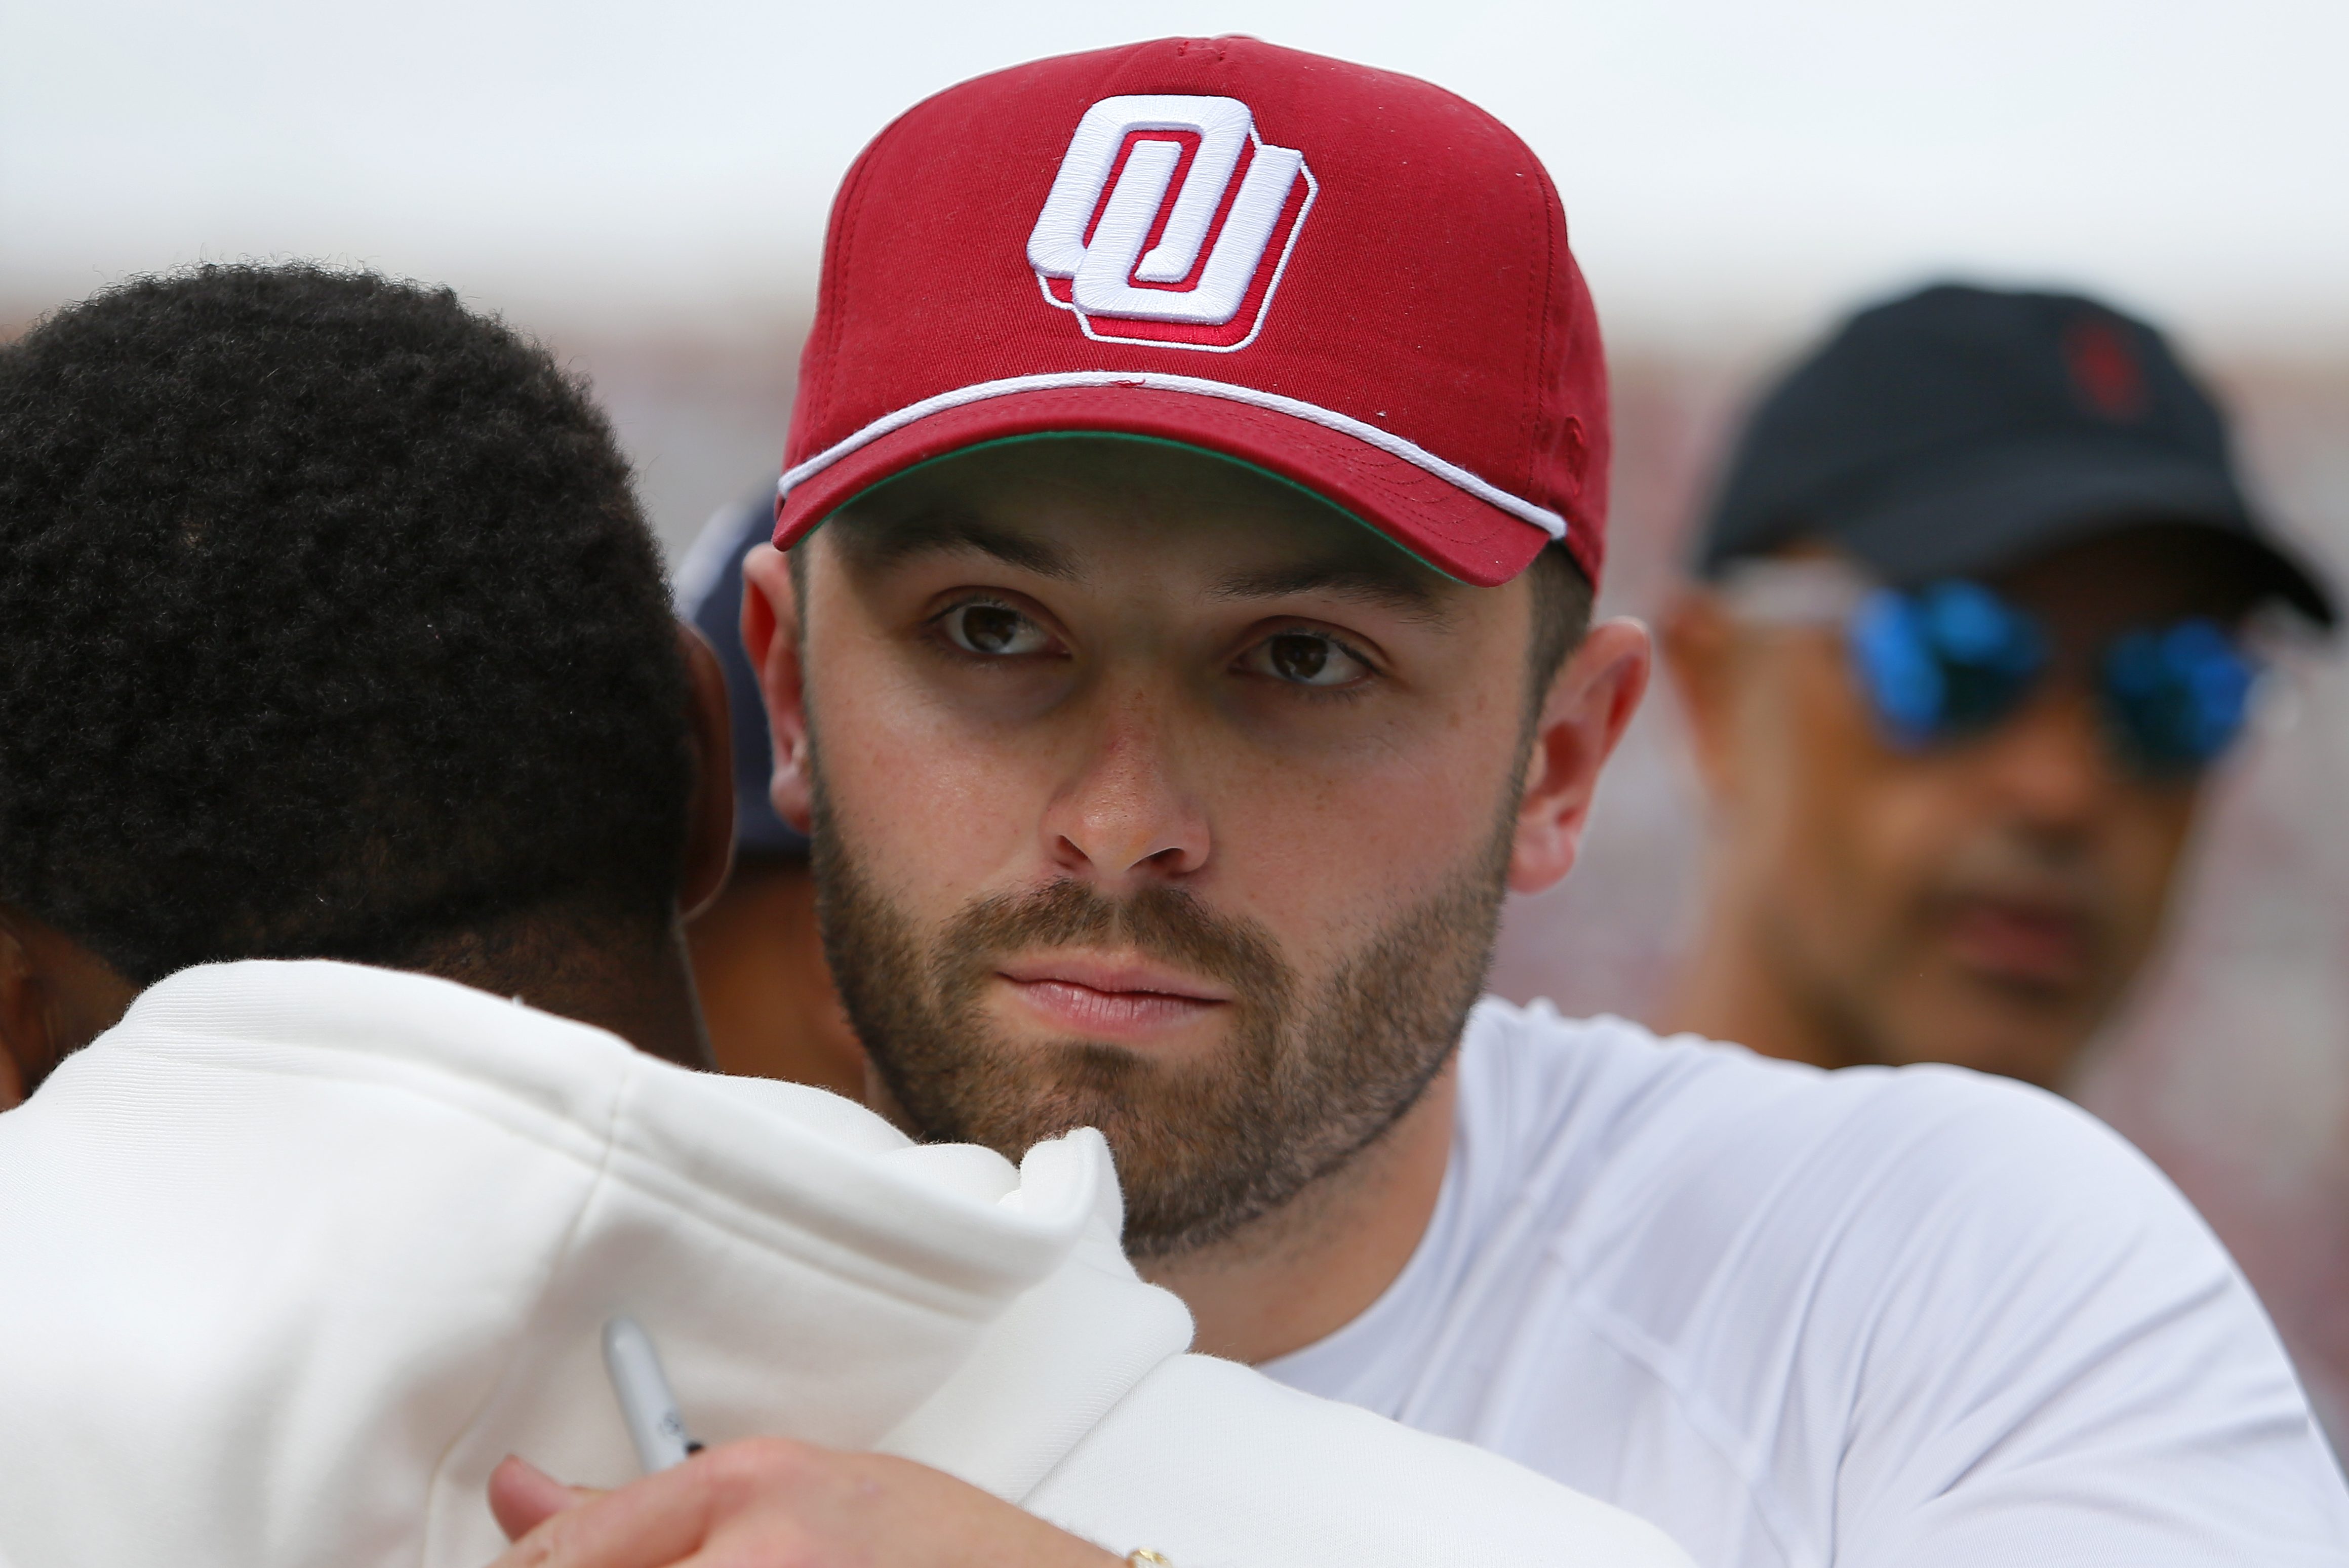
<box><xmin>1846</xmin><ymin>580</ymin><xmax>2260</xmax><ymax>777</ymax></box>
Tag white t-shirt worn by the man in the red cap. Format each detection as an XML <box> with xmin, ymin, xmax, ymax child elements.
<box><xmin>1264</xmin><ymin>1002</ymin><xmax>2349</xmax><ymax>1568</ymax></box>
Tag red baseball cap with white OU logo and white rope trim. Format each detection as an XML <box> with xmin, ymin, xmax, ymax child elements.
<box><xmin>775</xmin><ymin>37</ymin><xmax>1609</xmax><ymax>587</ymax></box>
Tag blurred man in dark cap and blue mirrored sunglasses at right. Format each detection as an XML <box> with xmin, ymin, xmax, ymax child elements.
<box><xmin>1663</xmin><ymin>287</ymin><xmax>2333</xmax><ymax>1087</ymax></box>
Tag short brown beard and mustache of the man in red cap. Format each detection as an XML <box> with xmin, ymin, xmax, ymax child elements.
<box><xmin>810</xmin><ymin>758</ymin><xmax>1515</xmax><ymax>1258</ymax></box>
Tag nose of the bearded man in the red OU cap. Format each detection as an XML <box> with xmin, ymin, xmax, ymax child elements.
<box><xmin>1043</xmin><ymin>700</ymin><xmax>1207</xmax><ymax>892</ymax></box>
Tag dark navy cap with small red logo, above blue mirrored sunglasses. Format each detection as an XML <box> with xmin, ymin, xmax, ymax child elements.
<box><xmin>1696</xmin><ymin>284</ymin><xmax>2335</xmax><ymax>627</ymax></box>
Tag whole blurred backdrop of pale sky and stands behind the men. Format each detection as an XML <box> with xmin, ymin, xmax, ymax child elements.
<box><xmin>0</xmin><ymin>0</ymin><xmax>2349</xmax><ymax>1441</ymax></box>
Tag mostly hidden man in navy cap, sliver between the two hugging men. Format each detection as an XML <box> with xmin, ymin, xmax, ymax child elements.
<box><xmin>676</xmin><ymin>486</ymin><xmax>864</xmax><ymax>1099</ymax></box>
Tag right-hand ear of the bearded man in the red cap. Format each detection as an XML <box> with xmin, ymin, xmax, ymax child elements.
<box><xmin>1508</xmin><ymin>620</ymin><xmax>1654</xmax><ymax>892</ymax></box>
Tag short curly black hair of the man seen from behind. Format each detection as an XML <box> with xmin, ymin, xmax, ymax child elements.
<box><xmin>0</xmin><ymin>265</ymin><xmax>693</xmax><ymax>984</ymax></box>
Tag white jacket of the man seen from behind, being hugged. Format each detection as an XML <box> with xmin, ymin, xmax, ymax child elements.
<box><xmin>0</xmin><ymin>962</ymin><xmax>1687</xmax><ymax>1568</ymax></box>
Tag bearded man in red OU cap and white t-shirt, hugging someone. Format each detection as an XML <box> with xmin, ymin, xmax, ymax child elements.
<box><xmin>495</xmin><ymin>37</ymin><xmax>2349</xmax><ymax>1568</ymax></box>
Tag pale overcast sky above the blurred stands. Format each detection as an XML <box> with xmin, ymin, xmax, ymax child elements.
<box><xmin>0</xmin><ymin>0</ymin><xmax>2349</xmax><ymax>352</ymax></box>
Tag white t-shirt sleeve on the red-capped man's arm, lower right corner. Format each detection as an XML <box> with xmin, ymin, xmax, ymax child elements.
<box><xmin>1832</xmin><ymin>1087</ymin><xmax>2349</xmax><ymax>1568</ymax></box>
